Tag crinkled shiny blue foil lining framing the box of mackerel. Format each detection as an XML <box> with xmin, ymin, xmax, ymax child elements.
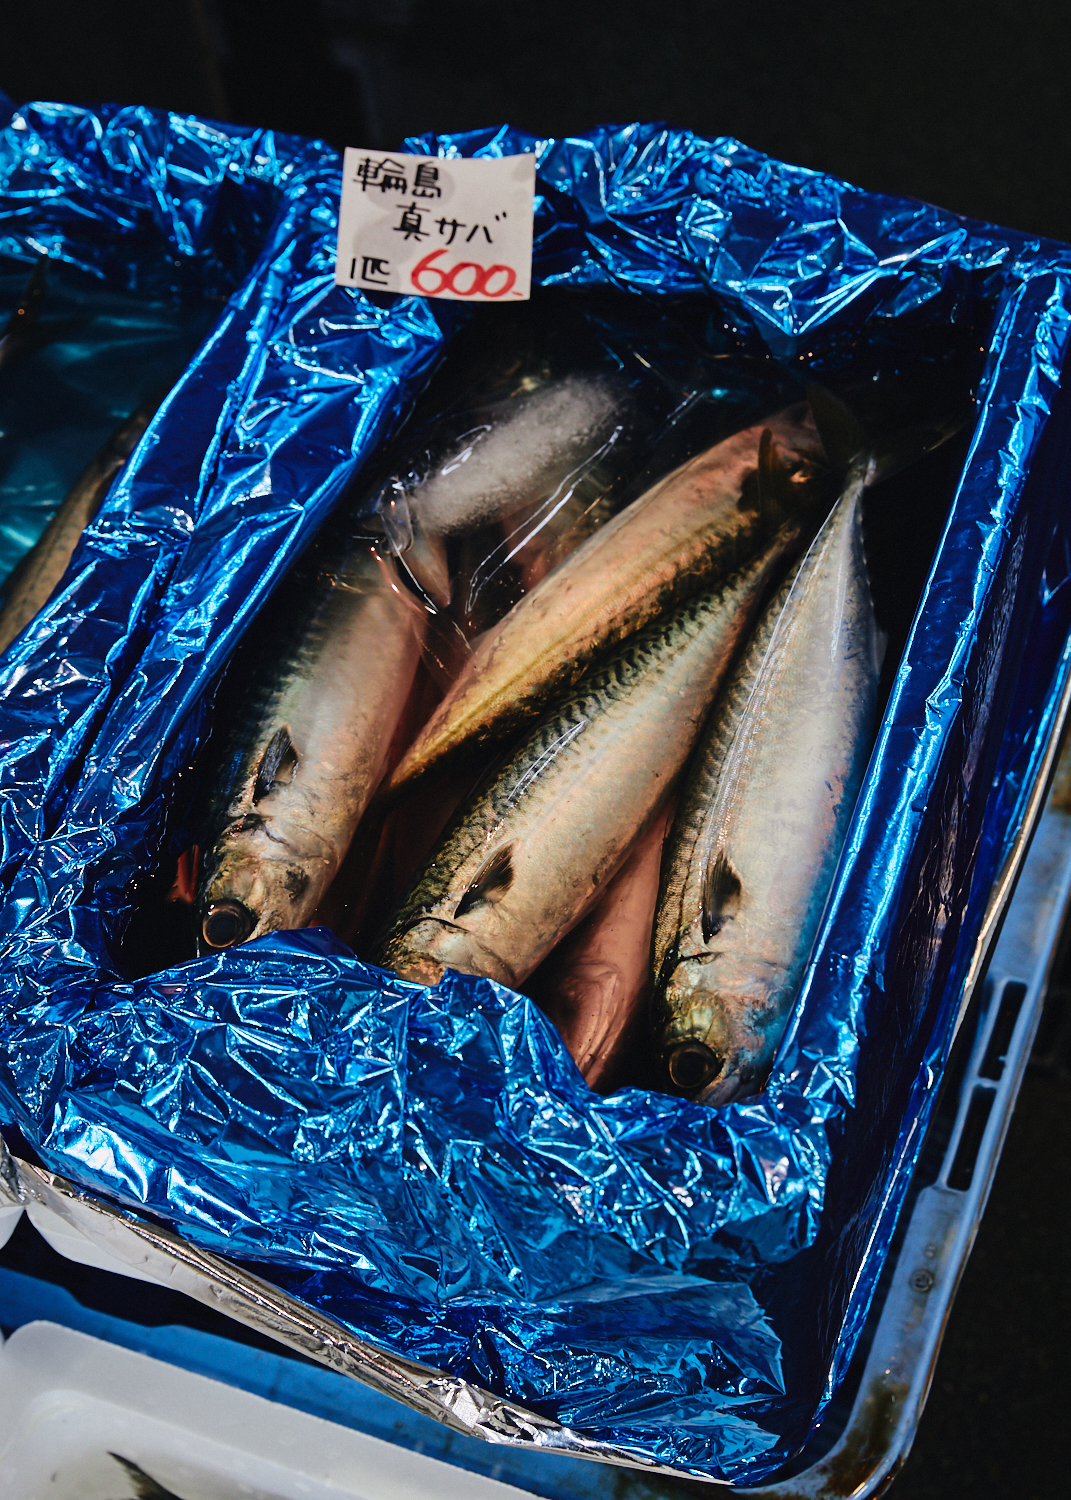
<box><xmin>0</xmin><ymin>107</ymin><xmax>1071</xmax><ymax>1482</ymax></box>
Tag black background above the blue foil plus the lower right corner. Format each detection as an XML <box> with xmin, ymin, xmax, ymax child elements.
<box><xmin>0</xmin><ymin>0</ymin><xmax>1071</xmax><ymax>1500</ymax></box>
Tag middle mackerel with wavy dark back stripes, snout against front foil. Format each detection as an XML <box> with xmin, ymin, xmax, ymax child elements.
<box><xmin>378</xmin><ymin>543</ymin><xmax>794</xmax><ymax>989</ymax></box>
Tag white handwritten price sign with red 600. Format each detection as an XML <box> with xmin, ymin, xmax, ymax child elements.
<box><xmin>335</xmin><ymin>146</ymin><xmax>536</xmax><ymax>302</ymax></box>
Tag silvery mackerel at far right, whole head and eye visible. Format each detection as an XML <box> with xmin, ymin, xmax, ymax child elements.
<box><xmin>653</xmin><ymin>462</ymin><xmax>884</xmax><ymax>1107</ymax></box>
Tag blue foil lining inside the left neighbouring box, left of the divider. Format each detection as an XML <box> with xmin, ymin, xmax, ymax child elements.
<box><xmin>0</xmin><ymin>96</ymin><xmax>337</xmax><ymax>582</ymax></box>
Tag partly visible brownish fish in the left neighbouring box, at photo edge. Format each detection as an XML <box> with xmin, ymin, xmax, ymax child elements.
<box><xmin>0</xmin><ymin>393</ymin><xmax>162</xmax><ymax>651</ymax></box>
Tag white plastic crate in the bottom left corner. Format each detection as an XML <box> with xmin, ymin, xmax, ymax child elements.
<box><xmin>0</xmin><ymin>1323</ymin><xmax>524</xmax><ymax>1500</ymax></box>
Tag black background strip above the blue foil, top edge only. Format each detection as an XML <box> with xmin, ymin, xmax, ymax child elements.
<box><xmin>0</xmin><ymin>0</ymin><xmax>1071</xmax><ymax>239</ymax></box>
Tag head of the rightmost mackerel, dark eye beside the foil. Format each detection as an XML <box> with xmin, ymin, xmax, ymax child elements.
<box><xmin>659</xmin><ymin>954</ymin><xmax>785</xmax><ymax>1109</ymax></box>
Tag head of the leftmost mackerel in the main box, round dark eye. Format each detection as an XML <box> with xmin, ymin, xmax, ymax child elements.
<box><xmin>198</xmin><ymin>815</ymin><xmax>333</xmax><ymax>951</ymax></box>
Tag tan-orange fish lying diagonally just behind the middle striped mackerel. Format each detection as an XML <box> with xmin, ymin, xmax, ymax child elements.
<box><xmin>387</xmin><ymin>408</ymin><xmax>825</xmax><ymax>795</ymax></box>
